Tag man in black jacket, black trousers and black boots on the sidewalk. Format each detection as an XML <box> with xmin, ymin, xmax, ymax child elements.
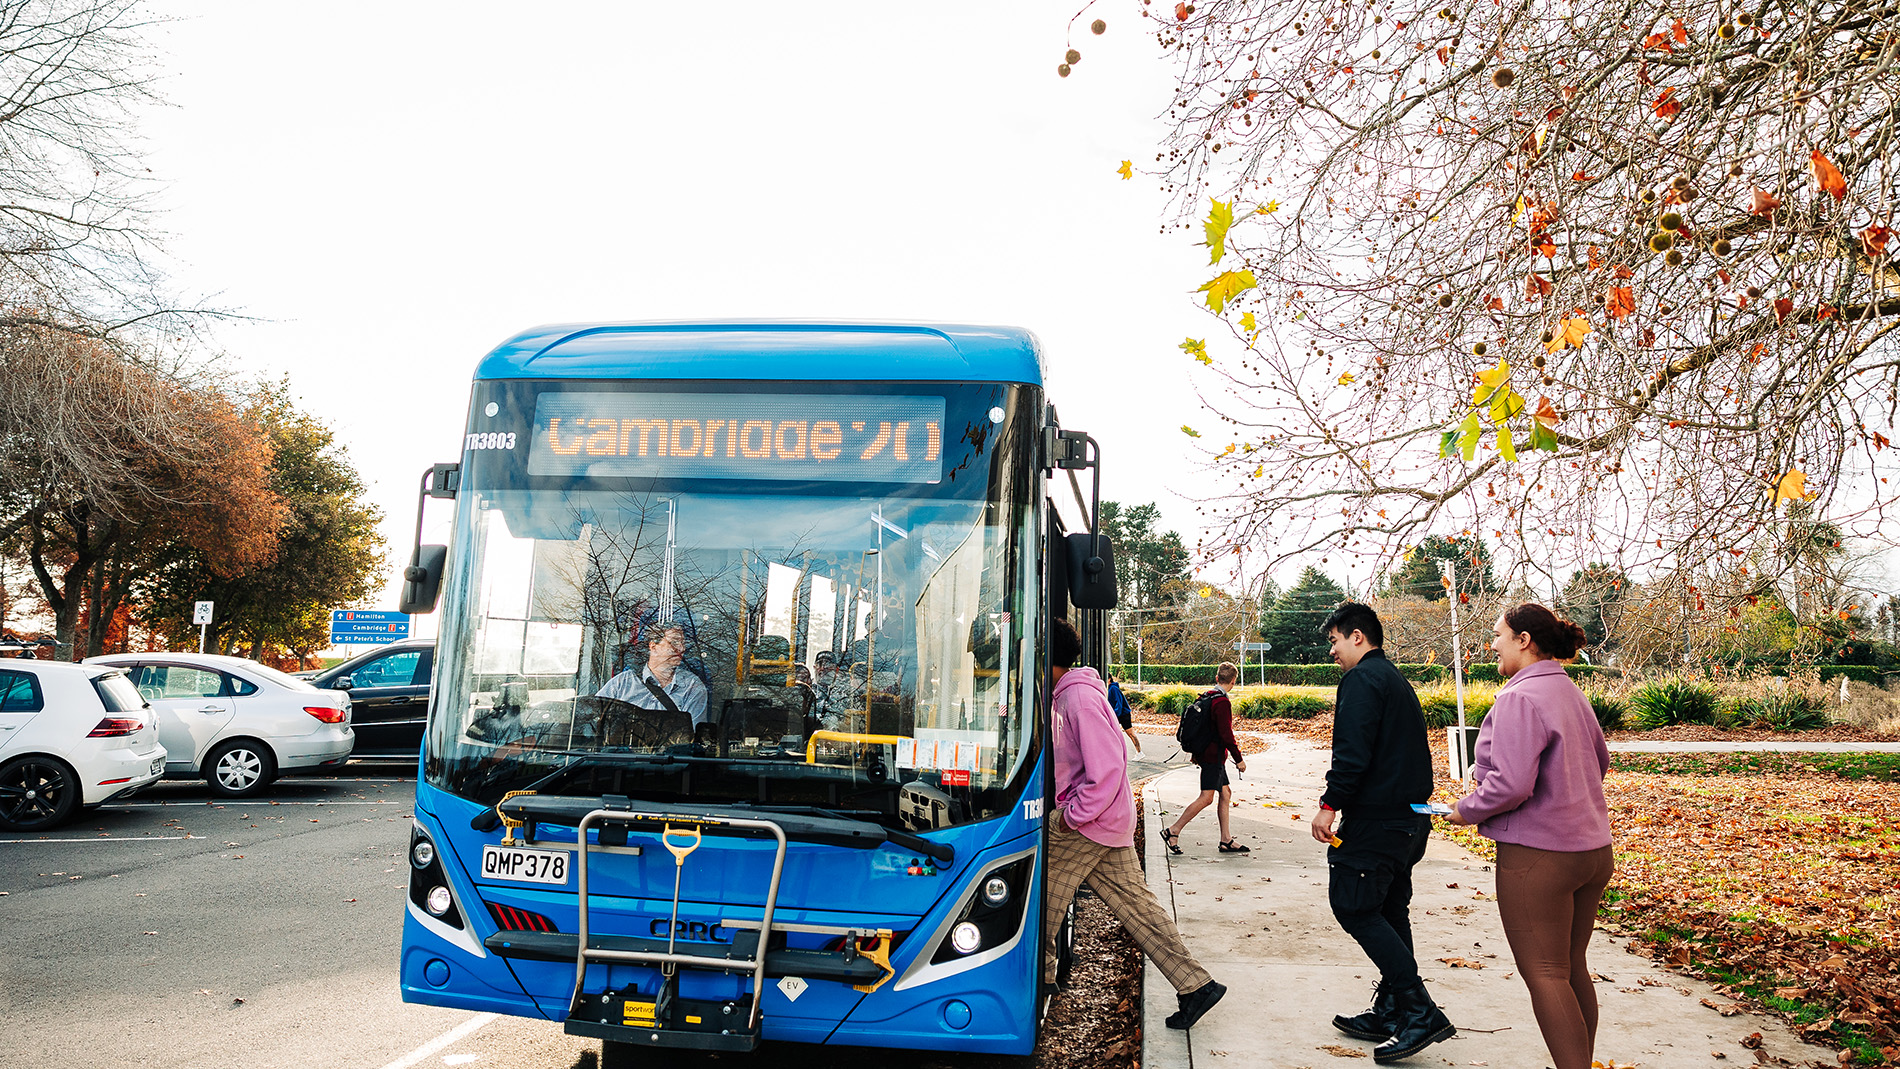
<box><xmin>1313</xmin><ymin>602</ymin><xmax>1457</xmax><ymax>1063</ymax></box>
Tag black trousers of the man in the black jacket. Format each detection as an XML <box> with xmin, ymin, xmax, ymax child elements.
<box><xmin>1326</xmin><ymin>816</ymin><xmax>1431</xmax><ymax>987</ymax></box>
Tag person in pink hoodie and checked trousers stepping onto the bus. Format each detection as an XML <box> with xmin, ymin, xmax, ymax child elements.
<box><xmin>1043</xmin><ymin>619</ymin><xmax>1227</xmax><ymax>1029</ymax></box>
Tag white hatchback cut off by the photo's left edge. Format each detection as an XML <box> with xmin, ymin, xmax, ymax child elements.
<box><xmin>0</xmin><ymin>659</ymin><xmax>165</xmax><ymax>832</ymax></box>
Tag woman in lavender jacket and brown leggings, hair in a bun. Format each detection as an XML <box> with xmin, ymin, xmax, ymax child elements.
<box><xmin>1450</xmin><ymin>604</ymin><xmax>1613</xmax><ymax>1069</ymax></box>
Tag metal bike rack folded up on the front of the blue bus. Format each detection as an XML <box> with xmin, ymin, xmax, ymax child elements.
<box><xmin>566</xmin><ymin>809</ymin><xmax>787</xmax><ymax>1050</ymax></box>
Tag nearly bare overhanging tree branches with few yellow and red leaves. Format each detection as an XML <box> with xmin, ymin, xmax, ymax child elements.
<box><xmin>1123</xmin><ymin>0</ymin><xmax>1900</xmax><ymax>600</ymax></box>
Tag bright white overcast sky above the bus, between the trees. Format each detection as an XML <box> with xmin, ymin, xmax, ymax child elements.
<box><xmin>143</xmin><ymin>0</ymin><xmax>1254</xmax><ymax>641</ymax></box>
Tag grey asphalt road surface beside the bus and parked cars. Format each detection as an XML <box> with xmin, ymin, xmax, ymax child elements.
<box><xmin>0</xmin><ymin>754</ymin><xmax>1102</xmax><ymax>1069</ymax></box>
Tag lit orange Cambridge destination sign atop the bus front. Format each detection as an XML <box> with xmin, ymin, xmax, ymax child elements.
<box><xmin>528</xmin><ymin>393</ymin><xmax>944</xmax><ymax>482</ymax></box>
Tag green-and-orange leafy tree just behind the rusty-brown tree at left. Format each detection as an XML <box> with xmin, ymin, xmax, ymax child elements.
<box><xmin>139</xmin><ymin>382</ymin><xmax>386</xmax><ymax>659</ymax></box>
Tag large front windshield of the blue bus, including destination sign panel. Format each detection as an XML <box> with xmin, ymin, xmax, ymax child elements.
<box><xmin>426</xmin><ymin>382</ymin><xmax>1039</xmax><ymax>830</ymax></box>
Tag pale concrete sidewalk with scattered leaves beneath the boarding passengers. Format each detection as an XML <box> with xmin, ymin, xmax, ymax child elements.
<box><xmin>1142</xmin><ymin>735</ymin><xmax>1834</xmax><ymax>1069</ymax></box>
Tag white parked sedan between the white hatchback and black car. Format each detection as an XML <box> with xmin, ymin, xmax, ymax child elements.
<box><xmin>86</xmin><ymin>653</ymin><xmax>355</xmax><ymax>797</ymax></box>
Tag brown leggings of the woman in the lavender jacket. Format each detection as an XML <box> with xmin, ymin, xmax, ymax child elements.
<box><xmin>1497</xmin><ymin>843</ymin><xmax>1615</xmax><ymax>1069</ymax></box>
